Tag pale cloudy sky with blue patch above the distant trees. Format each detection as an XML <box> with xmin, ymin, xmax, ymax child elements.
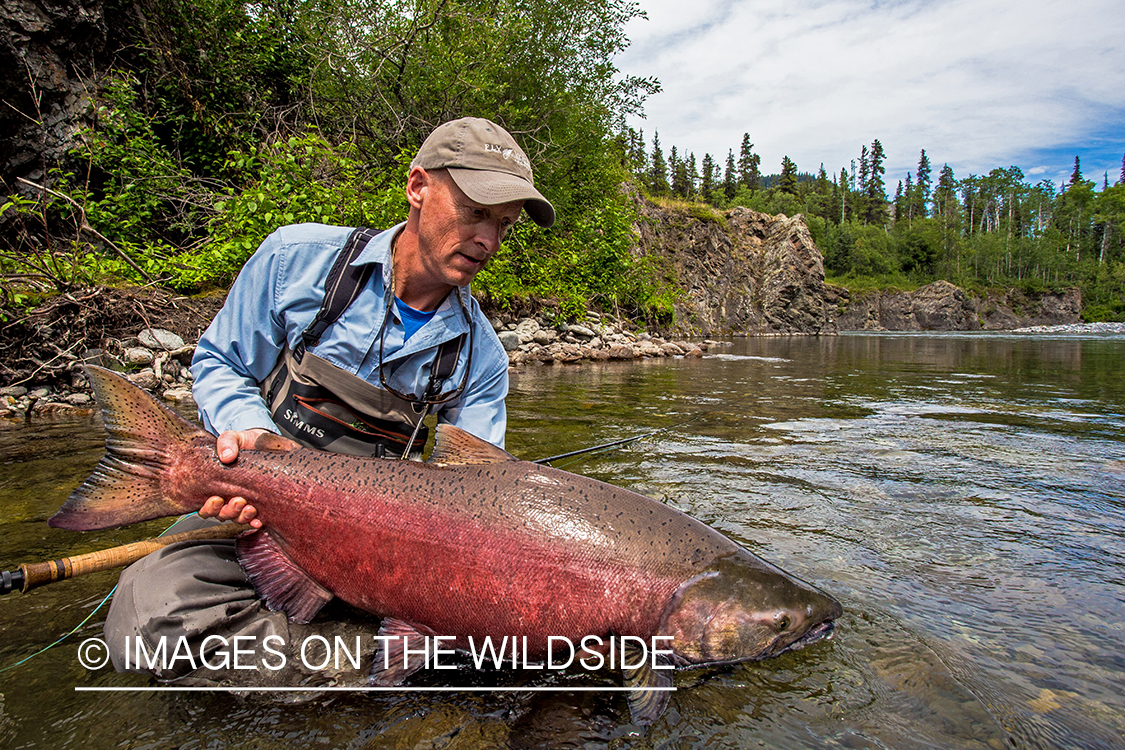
<box><xmin>617</xmin><ymin>0</ymin><xmax>1125</xmax><ymax>193</ymax></box>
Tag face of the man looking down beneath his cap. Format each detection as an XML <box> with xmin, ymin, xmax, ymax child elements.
<box><xmin>419</xmin><ymin>170</ymin><xmax>523</xmax><ymax>287</ymax></box>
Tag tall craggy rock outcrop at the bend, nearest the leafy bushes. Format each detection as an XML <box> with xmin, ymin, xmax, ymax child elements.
<box><xmin>638</xmin><ymin>200</ymin><xmax>838</xmax><ymax>336</ymax></box>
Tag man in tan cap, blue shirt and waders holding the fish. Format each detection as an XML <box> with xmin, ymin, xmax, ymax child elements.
<box><xmin>105</xmin><ymin>118</ymin><xmax>555</xmax><ymax>678</ymax></box>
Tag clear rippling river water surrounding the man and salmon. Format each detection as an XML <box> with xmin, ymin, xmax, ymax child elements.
<box><xmin>0</xmin><ymin>334</ymin><xmax>1125</xmax><ymax>749</ymax></box>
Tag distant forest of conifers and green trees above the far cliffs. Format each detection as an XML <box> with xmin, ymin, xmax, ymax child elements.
<box><xmin>621</xmin><ymin>128</ymin><xmax>1125</xmax><ymax>322</ymax></box>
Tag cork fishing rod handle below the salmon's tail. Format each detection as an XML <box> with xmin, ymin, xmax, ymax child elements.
<box><xmin>0</xmin><ymin>524</ymin><xmax>250</xmax><ymax>595</ymax></box>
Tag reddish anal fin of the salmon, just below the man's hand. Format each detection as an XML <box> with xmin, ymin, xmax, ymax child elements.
<box><xmin>234</xmin><ymin>531</ymin><xmax>332</xmax><ymax>623</ymax></box>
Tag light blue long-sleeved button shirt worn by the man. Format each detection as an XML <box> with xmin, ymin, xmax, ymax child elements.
<box><xmin>191</xmin><ymin>224</ymin><xmax>509</xmax><ymax>448</ymax></box>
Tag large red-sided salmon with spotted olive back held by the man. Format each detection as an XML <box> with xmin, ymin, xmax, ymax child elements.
<box><xmin>48</xmin><ymin>367</ymin><xmax>842</xmax><ymax>722</ymax></box>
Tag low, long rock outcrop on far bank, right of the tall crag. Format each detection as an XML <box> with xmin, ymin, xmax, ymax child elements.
<box><xmin>836</xmin><ymin>281</ymin><xmax>1082</xmax><ymax>331</ymax></box>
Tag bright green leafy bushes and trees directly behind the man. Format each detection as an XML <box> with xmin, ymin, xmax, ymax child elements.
<box><xmin>0</xmin><ymin>0</ymin><xmax>675</xmax><ymax>318</ymax></box>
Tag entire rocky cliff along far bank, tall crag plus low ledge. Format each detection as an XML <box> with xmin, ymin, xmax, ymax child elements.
<box><xmin>637</xmin><ymin>199</ymin><xmax>1082</xmax><ymax>336</ymax></box>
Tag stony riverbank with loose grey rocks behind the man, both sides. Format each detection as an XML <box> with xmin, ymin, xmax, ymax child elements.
<box><xmin>0</xmin><ymin>287</ymin><xmax>728</xmax><ymax>421</ymax></box>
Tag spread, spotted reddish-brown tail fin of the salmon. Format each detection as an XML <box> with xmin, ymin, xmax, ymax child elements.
<box><xmin>47</xmin><ymin>365</ymin><xmax>214</xmax><ymax>531</ymax></box>
